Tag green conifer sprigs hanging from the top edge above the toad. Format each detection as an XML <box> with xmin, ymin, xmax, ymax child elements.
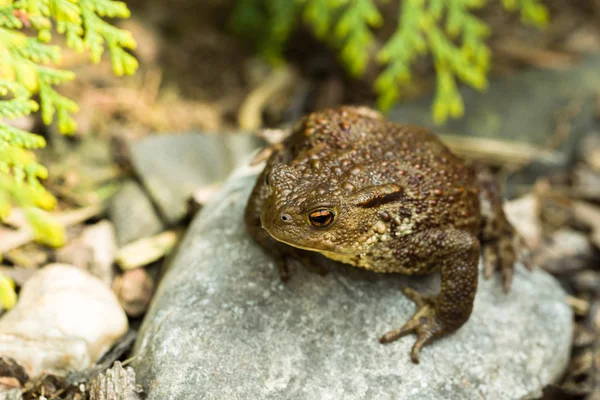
<box><xmin>231</xmin><ymin>0</ymin><xmax>548</xmax><ymax>123</ymax></box>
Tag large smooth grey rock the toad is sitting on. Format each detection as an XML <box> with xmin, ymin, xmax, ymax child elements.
<box><xmin>134</xmin><ymin>161</ymin><xmax>572</xmax><ymax>400</ymax></box>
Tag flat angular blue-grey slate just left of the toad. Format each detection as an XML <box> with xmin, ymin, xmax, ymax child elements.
<box><xmin>130</xmin><ymin>133</ymin><xmax>260</xmax><ymax>224</ymax></box>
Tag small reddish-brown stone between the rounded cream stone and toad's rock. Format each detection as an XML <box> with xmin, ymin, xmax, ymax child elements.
<box><xmin>113</xmin><ymin>268</ymin><xmax>154</xmax><ymax>317</ymax></box>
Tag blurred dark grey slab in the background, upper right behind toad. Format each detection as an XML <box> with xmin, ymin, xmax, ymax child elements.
<box><xmin>388</xmin><ymin>53</ymin><xmax>600</xmax><ymax>198</ymax></box>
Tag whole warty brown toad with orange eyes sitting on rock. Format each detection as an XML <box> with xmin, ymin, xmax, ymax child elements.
<box><xmin>245</xmin><ymin>106</ymin><xmax>516</xmax><ymax>363</ymax></box>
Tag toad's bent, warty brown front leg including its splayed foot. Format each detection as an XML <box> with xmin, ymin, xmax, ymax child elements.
<box><xmin>380</xmin><ymin>230</ymin><xmax>479</xmax><ymax>363</ymax></box>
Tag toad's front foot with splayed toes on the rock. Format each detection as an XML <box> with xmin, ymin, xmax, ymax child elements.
<box><xmin>379</xmin><ymin>288</ymin><xmax>445</xmax><ymax>364</ymax></box>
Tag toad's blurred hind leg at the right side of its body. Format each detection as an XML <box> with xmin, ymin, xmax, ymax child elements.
<box><xmin>477</xmin><ymin>166</ymin><xmax>527</xmax><ymax>293</ymax></box>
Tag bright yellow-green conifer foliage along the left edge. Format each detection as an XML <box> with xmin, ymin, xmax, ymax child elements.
<box><xmin>0</xmin><ymin>0</ymin><xmax>138</xmax><ymax>308</ymax></box>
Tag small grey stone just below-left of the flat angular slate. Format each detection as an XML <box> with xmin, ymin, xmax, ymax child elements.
<box><xmin>108</xmin><ymin>180</ymin><xmax>164</xmax><ymax>247</ymax></box>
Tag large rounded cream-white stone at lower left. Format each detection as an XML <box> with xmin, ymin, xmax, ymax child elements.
<box><xmin>0</xmin><ymin>264</ymin><xmax>128</xmax><ymax>379</ymax></box>
